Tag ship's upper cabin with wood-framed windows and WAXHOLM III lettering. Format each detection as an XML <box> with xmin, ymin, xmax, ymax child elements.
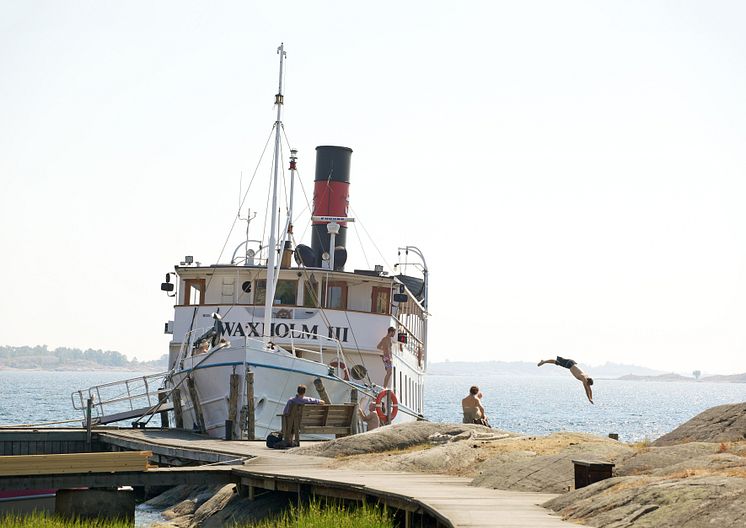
<box><xmin>164</xmin><ymin>261</ymin><xmax>427</xmax><ymax>371</ymax></box>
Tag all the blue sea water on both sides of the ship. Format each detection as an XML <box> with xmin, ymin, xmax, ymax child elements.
<box><xmin>0</xmin><ymin>370</ymin><xmax>746</xmax><ymax>442</ymax></box>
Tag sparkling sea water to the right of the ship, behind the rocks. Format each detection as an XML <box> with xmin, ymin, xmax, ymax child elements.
<box><xmin>425</xmin><ymin>375</ymin><xmax>746</xmax><ymax>442</ymax></box>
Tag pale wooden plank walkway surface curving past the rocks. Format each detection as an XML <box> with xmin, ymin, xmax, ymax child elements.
<box><xmin>99</xmin><ymin>429</ymin><xmax>577</xmax><ymax>528</ymax></box>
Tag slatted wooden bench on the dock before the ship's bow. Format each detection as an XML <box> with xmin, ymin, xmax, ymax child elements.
<box><xmin>282</xmin><ymin>403</ymin><xmax>357</xmax><ymax>446</ymax></box>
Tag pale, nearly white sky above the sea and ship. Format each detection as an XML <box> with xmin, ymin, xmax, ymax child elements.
<box><xmin>0</xmin><ymin>0</ymin><xmax>746</xmax><ymax>373</ymax></box>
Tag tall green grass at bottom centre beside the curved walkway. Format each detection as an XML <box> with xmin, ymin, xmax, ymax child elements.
<box><xmin>234</xmin><ymin>502</ymin><xmax>394</xmax><ymax>528</ymax></box>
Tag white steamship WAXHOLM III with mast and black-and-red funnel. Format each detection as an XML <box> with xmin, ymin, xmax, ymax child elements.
<box><xmin>162</xmin><ymin>46</ymin><xmax>428</xmax><ymax>438</ymax></box>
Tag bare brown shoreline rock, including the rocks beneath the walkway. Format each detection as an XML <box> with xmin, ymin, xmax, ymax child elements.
<box><xmin>144</xmin><ymin>403</ymin><xmax>746</xmax><ymax>528</ymax></box>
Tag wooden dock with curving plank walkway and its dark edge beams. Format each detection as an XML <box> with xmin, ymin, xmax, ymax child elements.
<box><xmin>0</xmin><ymin>429</ymin><xmax>576</xmax><ymax>528</ymax></box>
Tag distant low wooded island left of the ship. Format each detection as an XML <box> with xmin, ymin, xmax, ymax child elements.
<box><xmin>0</xmin><ymin>345</ymin><xmax>168</xmax><ymax>371</ymax></box>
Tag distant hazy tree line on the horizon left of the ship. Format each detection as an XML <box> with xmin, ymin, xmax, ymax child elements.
<box><xmin>0</xmin><ymin>345</ymin><xmax>167</xmax><ymax>368</ymax></box>
